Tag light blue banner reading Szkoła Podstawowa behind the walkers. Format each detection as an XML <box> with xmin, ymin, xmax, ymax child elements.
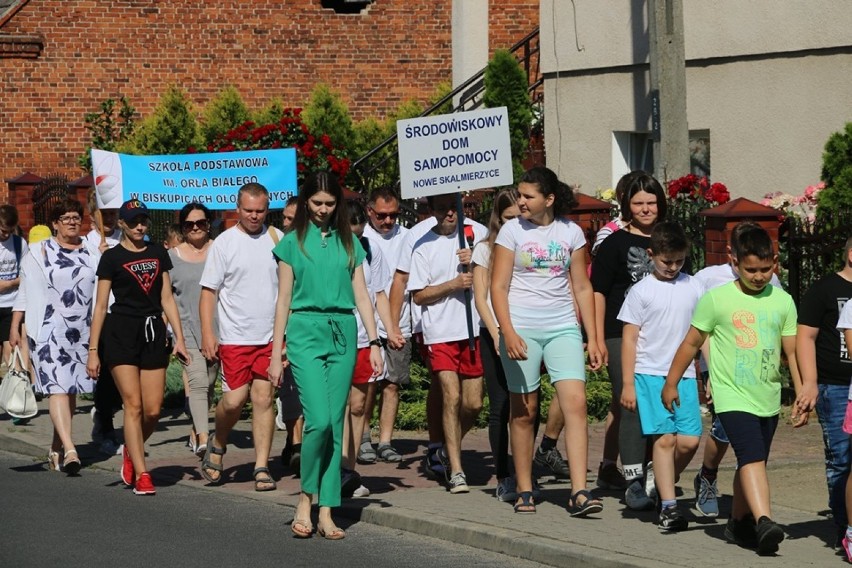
<box><xmin>92</xmin><ymin>148</ymin><xmax>297</xmax><ymax>209</ymax></box>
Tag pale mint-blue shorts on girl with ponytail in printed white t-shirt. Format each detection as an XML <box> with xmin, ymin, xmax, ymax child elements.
<box><xmin>500</xmin><ymin>325</ymin><xmax>586</xmax><ymax>393</ymax></box>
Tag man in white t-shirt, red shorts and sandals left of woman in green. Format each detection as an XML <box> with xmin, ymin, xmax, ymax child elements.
<box><xmin>199</xmin><ymin>183</ymin><xmax>283</xmax><ymax>491</ymax></box>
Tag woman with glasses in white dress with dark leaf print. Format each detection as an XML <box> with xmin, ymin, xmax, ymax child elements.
<box><xmin>9</xmin><ymin>199</ymin><xmax>97</xmax><ymax>475</ymax></box>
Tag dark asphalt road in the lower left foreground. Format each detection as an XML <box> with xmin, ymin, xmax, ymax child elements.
<box><xmin>0</xmin><ymin>452</ymin><xmax>542</xmax><ymax>568</ymax></box>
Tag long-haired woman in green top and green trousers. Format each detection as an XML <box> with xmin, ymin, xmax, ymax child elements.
<box><xmin>269</xmin><ymin>172</ymin><xmax>382</xmax><ymax>540</ymax></box>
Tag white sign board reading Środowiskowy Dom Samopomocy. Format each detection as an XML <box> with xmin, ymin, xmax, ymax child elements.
<box><xmin>396</xmin><ymin>107</ymin><xmax>514</xmax><ymax>199</ymax></box>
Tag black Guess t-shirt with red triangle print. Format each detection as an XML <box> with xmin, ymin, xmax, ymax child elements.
<box><xmin>98</xmin><ymin>243</ymin><xmax>172</xmax><ymax>317</ymax></box>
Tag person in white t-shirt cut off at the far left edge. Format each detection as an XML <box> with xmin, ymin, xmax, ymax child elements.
<box><xmin>0</xmin><ymin>205</ymin><xmax>29</xmax><ymax>363</ymax></box>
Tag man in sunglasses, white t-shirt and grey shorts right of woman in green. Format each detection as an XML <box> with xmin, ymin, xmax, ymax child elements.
<box><xmin>358</xmin><ymin>188</ymin><xmax>412</xmax><ymax>463</ymax></box>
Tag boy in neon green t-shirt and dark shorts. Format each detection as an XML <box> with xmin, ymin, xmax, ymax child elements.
<box><xmin>662</xmin><ymin>226</ymin><xmax>817</xmax><ymax>554</ymax></box>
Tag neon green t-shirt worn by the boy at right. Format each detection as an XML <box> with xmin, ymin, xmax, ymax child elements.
<box><xmin>692</xmin><ymin>282</ymin><xmax>796</xmax><ymax>417</ymax></box>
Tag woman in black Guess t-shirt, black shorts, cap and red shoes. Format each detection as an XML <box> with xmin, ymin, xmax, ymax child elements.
<box><xmin>87</xmin><ymin>199</ymin><xmax>190</xmax><ymax>495</ymax></box>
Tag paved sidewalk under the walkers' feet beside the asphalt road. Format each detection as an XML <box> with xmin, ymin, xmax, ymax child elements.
<box><xmin>0</xmin><ymin>401</ymin><xmax>844</xmax><ymax>568</ymax></box>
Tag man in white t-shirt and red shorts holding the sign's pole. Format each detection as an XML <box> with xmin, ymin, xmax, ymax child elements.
<box><xmin>408</xmin><ymin>194</ymin><xmax>487</xmax><ymax>493</ymax></box>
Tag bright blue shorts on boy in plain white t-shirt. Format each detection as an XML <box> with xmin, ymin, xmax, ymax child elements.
<box><xmin>635</xmin><ymin>373</ymin><xmax>701</xmax><ymax>437</ymax></box>
